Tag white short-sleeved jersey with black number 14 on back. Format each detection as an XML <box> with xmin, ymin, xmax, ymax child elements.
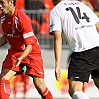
<box><xmin>50</xmin><ymin>0</ymin><xmax>99</xmax><ymax>52</ymax></box>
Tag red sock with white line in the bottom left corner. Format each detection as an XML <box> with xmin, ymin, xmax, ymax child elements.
<box><xmin>0</xmin><ymin>80</ymin><xmax>11</xmax><ymax>99</ymax></box>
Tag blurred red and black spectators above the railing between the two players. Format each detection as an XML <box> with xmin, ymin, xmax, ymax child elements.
<box><xmin>16</xmin><ymin>0</ymin><xmax>54</xmax><ymax>10</ymax></box>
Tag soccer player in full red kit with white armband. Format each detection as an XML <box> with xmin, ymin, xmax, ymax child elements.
<box><xmin>0</xmin><ymin>0</ymin><xmax>53</xmax><ymax>99</ymax></box>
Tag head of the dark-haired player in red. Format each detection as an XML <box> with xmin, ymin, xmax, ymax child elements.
<box><xmin>0</xmin><ymin>0</ymin><xmax>16</xmax><ymax>14</ymax></box>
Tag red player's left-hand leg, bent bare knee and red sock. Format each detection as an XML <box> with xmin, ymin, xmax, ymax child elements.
<box><xmin>0</xmin><ymin>69</ymin><xmax>16</xmax><ymax>99</ymax></box>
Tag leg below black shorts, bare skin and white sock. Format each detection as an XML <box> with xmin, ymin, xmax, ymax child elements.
<box><xmin>69</xmin><ymin>79</ymin><xmax>90</xmax><ymax>99</ymax></box>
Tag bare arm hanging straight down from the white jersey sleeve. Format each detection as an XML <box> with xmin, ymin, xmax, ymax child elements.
<box><xmin>53</xmin><ymin>31</ymin><xmax>62</xmax><ymax>81</ymax></box>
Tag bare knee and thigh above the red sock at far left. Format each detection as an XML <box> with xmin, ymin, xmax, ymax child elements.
<box><xmin>0</xmin><ymin>69</ymin><xmax>16</xmax><ymax>80</ymax></box>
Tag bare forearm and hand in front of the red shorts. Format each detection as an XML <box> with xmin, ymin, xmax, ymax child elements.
<box><xmin>15</xmin><ymin>45</ymin><xmax>32</xmax><ymax>67</ymax></box>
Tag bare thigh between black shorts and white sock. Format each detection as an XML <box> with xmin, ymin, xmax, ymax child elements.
<box><xmin>68</xmin><ymin>78</ymin><xmax>83</xmax><ymax>95</ymax></box>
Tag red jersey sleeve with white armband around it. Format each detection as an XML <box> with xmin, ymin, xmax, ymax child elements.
<box><xmin>22</xmin><ymin>16</ymin><xmax>35</xmax><ymax>45</ymax></box>
